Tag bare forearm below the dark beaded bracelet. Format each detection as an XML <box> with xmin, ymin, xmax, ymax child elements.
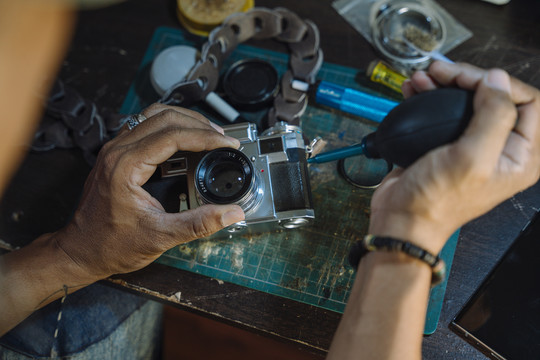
<box><xmin>328</xmin><ymin>252</ymin><xmax>431</xmax><ymax>360</ymax></box>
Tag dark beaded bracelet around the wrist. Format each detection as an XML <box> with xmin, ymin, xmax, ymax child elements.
<box><xmin>349</xmin><ymin>234</ymin><xmax>446</xmax><ymax>286</ymax></box>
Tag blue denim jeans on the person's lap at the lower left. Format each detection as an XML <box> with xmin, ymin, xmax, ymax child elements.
<box><xmin>0</xmin><ymin>284</ymin><xmax>162</xmax><ymax>360</ymax></box>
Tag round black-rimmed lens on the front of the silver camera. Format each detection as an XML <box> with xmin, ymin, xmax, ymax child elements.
<box><xmin>195</xmin><ymin>148</ymin><xmax>253</xmax><ymax>204</ymax></box>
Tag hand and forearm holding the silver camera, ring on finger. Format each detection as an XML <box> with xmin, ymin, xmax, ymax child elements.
<box><xmin>0</xmin><ymin>105</ymin><xmax>244</xmax><ymax>336</ymax></box>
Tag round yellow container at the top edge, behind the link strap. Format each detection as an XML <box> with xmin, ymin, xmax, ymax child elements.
<box><xmin>176</xmin><ymin>0</ymin><xmax>254</xmax><ymax>36</ymax></box>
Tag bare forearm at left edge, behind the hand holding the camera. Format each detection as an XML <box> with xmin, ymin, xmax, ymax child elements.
<box><xmin>0</xmin><ymin>233</ymin><xmax>94</xmax><ymax>336</ymax></box>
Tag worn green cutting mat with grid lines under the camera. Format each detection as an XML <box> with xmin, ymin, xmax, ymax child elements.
<box><xmin>121</xmin><ymin>28</ymin><xmax>457</xmax><ymax>334</ymax></box>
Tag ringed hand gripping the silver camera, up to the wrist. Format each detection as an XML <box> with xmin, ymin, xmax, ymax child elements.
<box><xmin>54</xmin><ymin>105</ymin><xmax>244</xmax><ymax>280</ymax></box>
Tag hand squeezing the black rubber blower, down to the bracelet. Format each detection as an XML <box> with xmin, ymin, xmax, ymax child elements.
<box><xmin>370</xmin><ymin>62</ymin><xmax>540</xmax><ymax>253</ymax></box>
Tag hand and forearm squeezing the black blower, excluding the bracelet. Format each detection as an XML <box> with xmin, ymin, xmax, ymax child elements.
<box><xmin>328</xmin><ymin>62</ymin><xmax>540</xmax><ymax>360</ymax></box>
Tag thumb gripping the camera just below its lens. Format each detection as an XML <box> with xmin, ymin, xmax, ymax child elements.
<box><xmin>163</xmin><ymin>205</ymin><xmax>245</xmax><ymax>246</ymax></box>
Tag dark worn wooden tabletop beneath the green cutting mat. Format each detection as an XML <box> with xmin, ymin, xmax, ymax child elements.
<box><xmin>0</xmin><ymin>0</ymin><xmax>540</xmax><ymax>359</ymax></box>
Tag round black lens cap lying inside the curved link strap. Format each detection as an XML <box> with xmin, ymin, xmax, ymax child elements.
<box><xmin>223</xmin><ymin>59</ymin><xmax>279</xmax><ymax>110</ymax></box>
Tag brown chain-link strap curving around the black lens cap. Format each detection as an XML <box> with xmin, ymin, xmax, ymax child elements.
<box><xmin>160</xmin><ymin>7</ymin><xmax>323</xmax><ymax>126</ymax></box>
